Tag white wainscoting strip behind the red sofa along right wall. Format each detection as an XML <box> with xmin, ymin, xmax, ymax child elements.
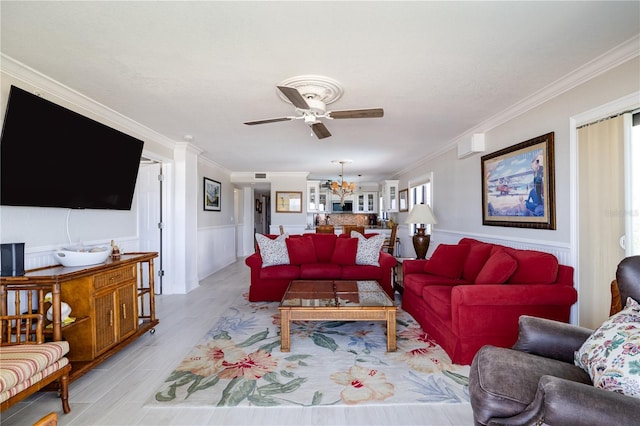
<box><xmin>429</xmin><ymin>230</ymin><xmax>574</xmax><ymax>266</ymax></box>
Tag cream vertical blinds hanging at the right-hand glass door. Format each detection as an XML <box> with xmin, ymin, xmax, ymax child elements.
<box><xmin>578</xmin><ymin>116</ymin><xmax>625</xmax><ymax>328</ymax></box>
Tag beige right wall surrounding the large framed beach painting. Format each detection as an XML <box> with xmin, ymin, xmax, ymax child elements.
<box><xmin>399</xmin><ymin>57</ymin><xmax>640</xmax><ymax>322</ymax></box>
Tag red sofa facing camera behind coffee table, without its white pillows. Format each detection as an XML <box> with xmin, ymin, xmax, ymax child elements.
<box><xmin>245</xmin><ymin>234</ymin><xmax>397</xmax><ymax>302</ymax></box>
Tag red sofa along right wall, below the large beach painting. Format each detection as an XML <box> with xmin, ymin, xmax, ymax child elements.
<box><xmin>402</xmin><ymin>238</ymin><xmax>578</xmax><ymax>364</ymax></box>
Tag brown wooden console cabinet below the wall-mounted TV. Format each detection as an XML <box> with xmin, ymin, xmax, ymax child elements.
<box><xmin>0</xmin><ymin>253</ymin><xmax>159</xmax><ymax>381</ymax></box>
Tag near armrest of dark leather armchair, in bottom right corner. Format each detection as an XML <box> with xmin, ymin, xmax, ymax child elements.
<box><xmin>488</xmin><ymin>376</ymin><xmax>640</xmax><ymax>425</ymax></box>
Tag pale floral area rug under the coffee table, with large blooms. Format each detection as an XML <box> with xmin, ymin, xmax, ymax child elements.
<box><xmin>147</xmin><ymin>296</ymin><xmax>469</xmax><ymax>407</ymax></box>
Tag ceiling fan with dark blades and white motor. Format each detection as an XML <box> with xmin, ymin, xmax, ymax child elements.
<box><xmin>244</xmin><ymin>86</ymin><xmax>384</xmax><ymax>139</ymax></box>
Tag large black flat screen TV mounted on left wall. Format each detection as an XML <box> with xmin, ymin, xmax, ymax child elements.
<box><xmin>0</xmin><ymin>86</ymin><xmax>143</xmax><ymax>210</ymax></box>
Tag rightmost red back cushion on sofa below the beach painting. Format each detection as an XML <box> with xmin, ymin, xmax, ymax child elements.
<box><xmin>505</xmin><ymin>248</ymin><xmax>558</xmax><ymax>284</ymax></box>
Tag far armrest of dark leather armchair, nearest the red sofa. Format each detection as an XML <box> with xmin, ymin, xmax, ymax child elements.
<box><xmin>512</xmin><ymin>315</ymin><xmax>593</xmax><ymax>364</ymax></box>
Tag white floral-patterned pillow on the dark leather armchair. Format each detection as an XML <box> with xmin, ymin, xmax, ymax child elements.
<box><xmin>574</xmin><ymin>297</ymin><xmax>640</xmax><ymax>398</ymax></box>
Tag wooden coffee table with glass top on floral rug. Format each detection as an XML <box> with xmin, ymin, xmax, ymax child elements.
<box><xmin>278</xmin><ymin>280</ymin><xmax>396</xmax><ymax>352</ymax></box>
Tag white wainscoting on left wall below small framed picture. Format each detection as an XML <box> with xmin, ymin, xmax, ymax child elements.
<box><xmin>198</xmin><ymin>225</ymin><xmax>236</xmax><ymax>280</ymax></box>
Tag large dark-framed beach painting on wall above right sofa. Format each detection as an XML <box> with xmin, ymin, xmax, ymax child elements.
<box><xmin>481</xmin><ymin>132</ymin><xmax>556</xmax><ymax>229</ymax></box>
